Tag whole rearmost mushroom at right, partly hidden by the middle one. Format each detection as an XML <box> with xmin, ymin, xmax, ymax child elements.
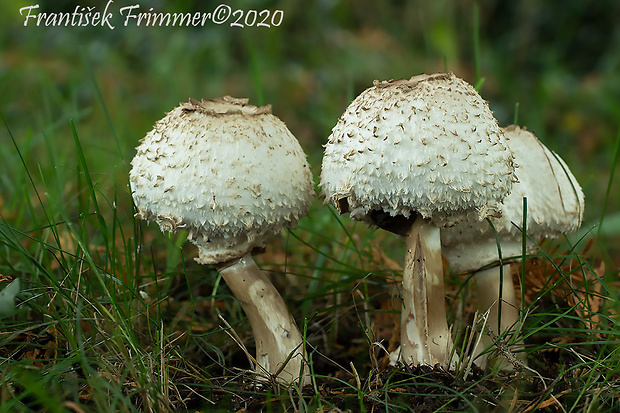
<box><xmin>441</xmin><ymin>125</ymin><xmax>584</xmax><ymax>369</ymax></box>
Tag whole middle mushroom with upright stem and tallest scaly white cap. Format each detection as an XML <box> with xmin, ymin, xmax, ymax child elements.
<box><xmin>320</xmin><ymin>73</ymin><xmax>515</xmax><ymax>367</ymax></box>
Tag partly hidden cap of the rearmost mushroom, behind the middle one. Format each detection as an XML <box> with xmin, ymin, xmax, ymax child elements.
<box><xmin>441</xmin><ymin>125</ymin><xmax>584</xmax><ymax>271</ymax></box>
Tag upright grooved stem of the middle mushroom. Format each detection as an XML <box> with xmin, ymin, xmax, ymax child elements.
<box><xmin>400</xmin><ymin>216</ymin><xmax>452</xmax><ymax>367</ymax></box>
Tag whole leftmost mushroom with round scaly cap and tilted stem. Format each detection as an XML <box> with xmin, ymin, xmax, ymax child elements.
<box><xmin>130</xmin><ymin>96</ymin><xmax>314</xmax><ymax>384</ymax></box>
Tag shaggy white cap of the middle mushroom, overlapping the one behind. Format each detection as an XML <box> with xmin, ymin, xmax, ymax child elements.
<box><xmin>320</xmin><ymin>73</ymin><xmax>515</xmax><ymax>227</ymax></box>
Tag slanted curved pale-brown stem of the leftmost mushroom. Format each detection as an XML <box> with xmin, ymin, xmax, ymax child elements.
<box><xmin>217</xmin><ymin>254</ymin><xmax>308</xmax><ymax>386</ymax></box>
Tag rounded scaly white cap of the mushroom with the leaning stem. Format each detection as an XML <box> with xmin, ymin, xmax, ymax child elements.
<box><xmin>129</xmin><ymin>96</ymin><xmax>314</xmax><ymax>264</ymax></box>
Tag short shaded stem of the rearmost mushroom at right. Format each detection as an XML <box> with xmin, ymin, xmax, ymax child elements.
<box><xmin>473</xmin><ymin>264</ymin><xmax>524</xmax><ymax>370</ymax></box>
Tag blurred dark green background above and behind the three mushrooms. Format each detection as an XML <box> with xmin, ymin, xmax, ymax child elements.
<box><xmin>0</xmin><ymin>0</ymin><xmax>620</xmax><ymax>265</ymax></box>
